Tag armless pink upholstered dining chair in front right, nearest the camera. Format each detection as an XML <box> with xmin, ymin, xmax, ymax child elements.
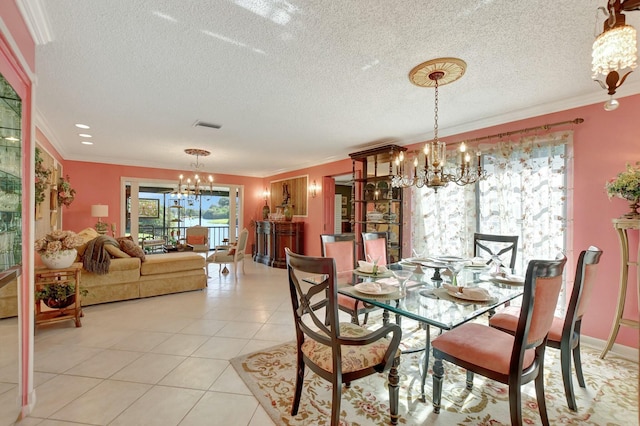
<box><xmin>431</xmin><ymin>256</ymin><xmax>567</xmax><ymax>425</ymax></box>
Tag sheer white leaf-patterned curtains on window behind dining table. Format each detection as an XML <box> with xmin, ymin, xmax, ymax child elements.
<box><xmin>411</xmin><ymin>131</ymin><xmax>573</xmax><ymax>273</ymax></box>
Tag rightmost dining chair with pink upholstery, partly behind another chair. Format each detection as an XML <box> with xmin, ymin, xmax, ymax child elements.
<box><xmin>489</xmin><ymin>246</ymin><xmax>602</xmax><ymax>411</ymax></box>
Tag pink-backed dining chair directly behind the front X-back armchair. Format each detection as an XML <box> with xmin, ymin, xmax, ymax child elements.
<box><xmin>320</xmin><ymin>234</ymin><xmax>373</xmax><ymax>324</ymax></box>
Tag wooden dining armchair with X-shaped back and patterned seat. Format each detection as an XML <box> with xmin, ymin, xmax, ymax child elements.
<box><xmin>285</xmin><ymin>248</ymin><xmax>402</xmax><ymax>426</ymax></box>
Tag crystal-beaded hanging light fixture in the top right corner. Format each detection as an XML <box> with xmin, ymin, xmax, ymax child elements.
<box><xmin>591</xmin><ymin>0</ymin><xmax>640</xmax><ymax>111</ymax></box>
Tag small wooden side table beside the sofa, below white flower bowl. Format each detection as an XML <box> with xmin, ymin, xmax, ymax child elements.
<box><xmin>34</xmin><ymin>262</ymin><xmax>83</xmax><ymax>327</ymax></box>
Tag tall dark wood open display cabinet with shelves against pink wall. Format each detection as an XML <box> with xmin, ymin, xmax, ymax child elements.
<box><xmin>349</xmin><ymin>145</ymin><xmax>406</xmax><ymax>262</ymax></box>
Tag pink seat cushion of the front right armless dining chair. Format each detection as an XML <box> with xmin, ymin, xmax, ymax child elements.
<box><xmin>431</xmin><ymin>323</ymin><xmax>535</xmax><ymax>375</ymax></box>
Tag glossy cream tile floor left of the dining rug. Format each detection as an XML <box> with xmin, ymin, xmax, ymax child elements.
<box><xmin>0</xmin><ymin>260</ymin><xmax>310</xmax><ymax>426</ymax></box>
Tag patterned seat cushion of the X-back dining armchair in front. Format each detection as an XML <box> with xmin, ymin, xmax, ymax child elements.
<box><xmin>300</xmin><ymin>323</ymin><xmax>400</xmax><ymax>373</ymax></box>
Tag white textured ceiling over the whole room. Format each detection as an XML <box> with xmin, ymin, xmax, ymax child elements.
<box><xmin>30</xmin><ymin>0</ymin><xmax>640</xmax><ymax>177</ymax></box>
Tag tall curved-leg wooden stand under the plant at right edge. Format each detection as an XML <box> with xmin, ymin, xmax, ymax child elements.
<box><xmin>600</xmin><ymin>219</ymin><xmax>640</xmax><ymax>358</ymax></box>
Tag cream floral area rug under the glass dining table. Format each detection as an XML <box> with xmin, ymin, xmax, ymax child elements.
<box><xmin>231</xmin><ymin>327</ymin><xmax>638</xmax><ymax>426</ymax></box>
